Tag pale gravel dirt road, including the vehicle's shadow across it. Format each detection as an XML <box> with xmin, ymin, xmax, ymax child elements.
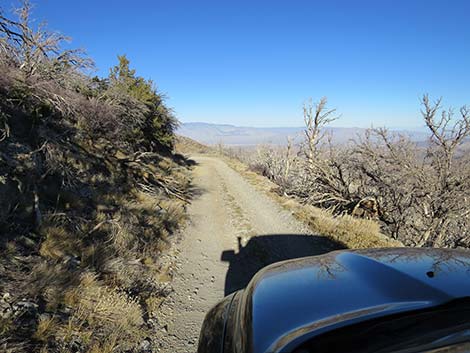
<box><xmin>157</xmin><ymin>156</ymin><xmax>342</xmax><ymax>353</ymax></box>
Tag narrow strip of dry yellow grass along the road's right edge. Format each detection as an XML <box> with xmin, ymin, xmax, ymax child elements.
<box><xmin>221</xmin><ymin>156</ymin><xmax>403</xmax><ymax>249</ymax></box>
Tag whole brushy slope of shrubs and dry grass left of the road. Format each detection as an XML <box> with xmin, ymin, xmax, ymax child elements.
<box><xmin>0</xmin><ymin>1</ymin><xmax>193</xmax><ymax>352</ymax></box>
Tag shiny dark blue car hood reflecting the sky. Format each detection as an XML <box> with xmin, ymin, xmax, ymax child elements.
<box><xmin>237</xmin><ymin>248</ymin><xmax>470</xmax><ymax>353</ymax></box>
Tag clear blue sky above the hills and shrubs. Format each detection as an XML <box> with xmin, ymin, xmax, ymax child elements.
<box><xmin>6</xmin><ymin>0</ymin><xmax>470</xmax><ymax>127</ymax></box>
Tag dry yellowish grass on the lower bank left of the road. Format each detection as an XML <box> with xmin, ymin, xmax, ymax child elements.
<box><xmin>0</xmin><ymin>148</ymin><xmax>189</xmax><ymax>352</ymax></box>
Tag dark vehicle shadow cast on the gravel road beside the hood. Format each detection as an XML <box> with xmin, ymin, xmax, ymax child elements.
<box><xmin>221</xmin><ymin>234</ymin><xmax>345</xmax><ymax>295</ymax></box>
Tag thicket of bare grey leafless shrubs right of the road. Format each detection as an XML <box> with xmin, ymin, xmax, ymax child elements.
<box><xmin>226</xmin><ymin>96</ymin><xmax>470</xmax><ymax>248</ymax></box>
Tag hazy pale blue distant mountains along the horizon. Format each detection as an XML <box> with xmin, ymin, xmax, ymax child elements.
<box><xmin>177</xmin><ymin>123</ymin><xmax>428</xmax><ymax>146</ymax></box>
